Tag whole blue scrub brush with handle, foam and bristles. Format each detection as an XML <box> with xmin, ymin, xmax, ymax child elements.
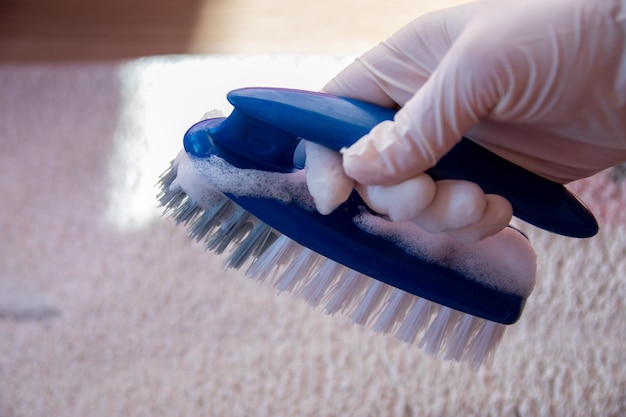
<box><xmin>159</xmin><ymin>88</ymin><xmax>598</xmax><ymax>368</ymax></box>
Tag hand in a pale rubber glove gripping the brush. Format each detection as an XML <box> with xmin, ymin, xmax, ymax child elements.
<box><xmin>307</xmin><ymin>0</ymin><xmax>626</xmax><ymax>241</ymax></box>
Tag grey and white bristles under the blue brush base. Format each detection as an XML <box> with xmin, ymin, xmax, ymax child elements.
<box><xmin>158</xmin><ymin>163</ymin><xmax>506</xmax><ymax>369</ymax></box>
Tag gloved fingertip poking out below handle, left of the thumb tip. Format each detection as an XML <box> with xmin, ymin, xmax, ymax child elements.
<box><xmin>305</xmin><ymin>141</ymin><xmax>354</xmax><ymax>214</ymax></box>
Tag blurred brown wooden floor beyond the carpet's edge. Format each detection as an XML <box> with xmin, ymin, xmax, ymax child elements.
<box><xmin>0</xmin><ymin>0</ymin><xmax>467</xmax><ymax>62</ymax></box>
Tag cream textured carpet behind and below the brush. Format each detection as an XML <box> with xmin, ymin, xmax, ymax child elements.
<box><xmin>0</xmin><ymin>56</ymin><xmax>626</xmax><ymax>417</ymax></box>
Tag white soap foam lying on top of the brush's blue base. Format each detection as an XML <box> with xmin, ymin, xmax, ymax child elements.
<box><xmin>172</xmin><ymin>152</ymin><xmax>536</xmax><ymax>297</ymax></box>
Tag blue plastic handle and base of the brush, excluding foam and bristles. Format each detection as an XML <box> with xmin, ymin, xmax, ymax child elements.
<box><xmin>184</xmin><ymin>88</ymin><xmax>598</xmax><ymax>324</ymax></box>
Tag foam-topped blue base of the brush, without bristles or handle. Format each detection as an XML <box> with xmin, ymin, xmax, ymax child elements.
<box><xmin>171</xmin><ymin>153</ymin><xmax>535</xmax><ymax>324</ymax></box>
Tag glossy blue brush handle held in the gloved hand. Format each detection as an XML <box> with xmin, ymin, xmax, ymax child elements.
<box><xmin>186</xmin><ymin>88</ymin><xmax>598</xmax><ymax>238</ymax></box>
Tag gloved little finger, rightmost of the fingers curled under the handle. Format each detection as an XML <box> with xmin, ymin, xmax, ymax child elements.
<box><xmin>447</xmin><ymin>194</ymin><xmax>513</xmax><ymax>243</ymax></box>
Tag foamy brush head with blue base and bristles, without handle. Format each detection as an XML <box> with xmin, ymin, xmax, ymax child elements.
<box><xmin>159</xmin><ymin>151</ymin><xmax>535</xmax><ymax>368</ymax></box>
